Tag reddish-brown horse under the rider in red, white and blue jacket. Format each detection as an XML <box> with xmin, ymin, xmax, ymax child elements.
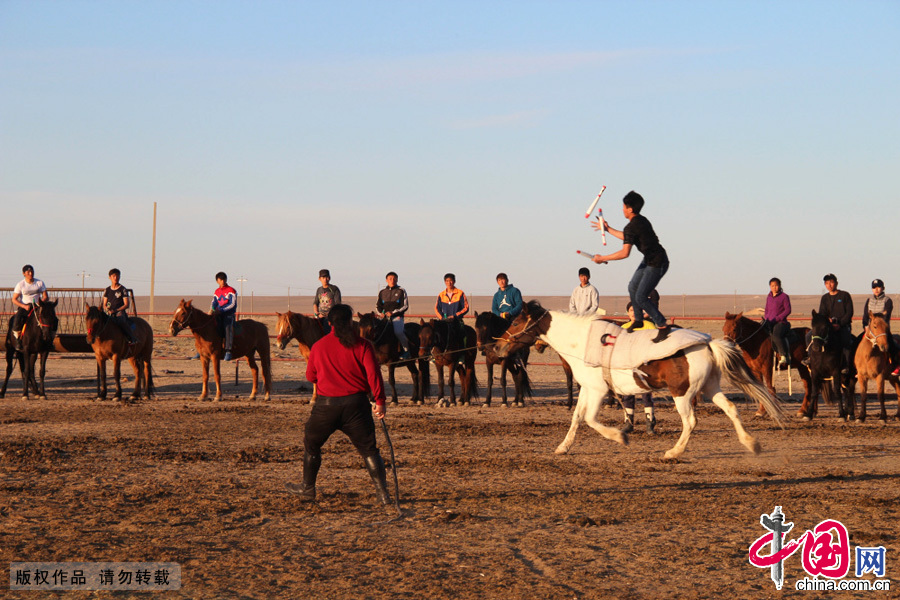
<box><xmin>169</xmin><ymin>299</ymin><xmax>272</xmax><ymax>401</ymax></box>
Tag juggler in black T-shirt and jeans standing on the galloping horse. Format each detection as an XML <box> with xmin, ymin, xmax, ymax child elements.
<box><xmin>591</xmin><ymin>191</ymin><xmax>669</xmax><ymax>342</ymax></box>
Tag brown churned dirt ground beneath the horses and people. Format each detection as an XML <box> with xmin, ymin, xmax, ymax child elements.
<box><xmin>0</xmin><ymin>340</ymin><xmax>900</xmax><ymax>600</ymax></box>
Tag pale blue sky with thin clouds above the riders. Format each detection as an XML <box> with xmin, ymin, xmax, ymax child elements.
<box><xmin>0</xmin><ymin>0</ymin><xmax>900</xmax><ymax>297</ymax></box>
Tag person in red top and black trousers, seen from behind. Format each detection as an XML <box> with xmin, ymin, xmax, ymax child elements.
<box><xmin>286</xmin><ymin>304</ymin><xmax>391</xmax><ymax>505</ymax></box>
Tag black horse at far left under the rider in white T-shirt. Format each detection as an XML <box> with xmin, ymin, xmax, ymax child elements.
<box><xmin>0</xmin><ymin>300</ymin><xmax>59</xmax><ymax>400</ymax></box>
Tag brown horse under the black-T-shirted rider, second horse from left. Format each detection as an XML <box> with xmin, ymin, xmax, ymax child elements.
<box><xmin>84</xmin><ymin>306</ymin><xmax>155</xmax><ymax>401</ymax></box>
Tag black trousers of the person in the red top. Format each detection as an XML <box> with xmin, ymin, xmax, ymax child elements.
<box><xmin>303</xmin><ymin>393</ymin><xmax>378</xmax><ymax>457</ymax></box>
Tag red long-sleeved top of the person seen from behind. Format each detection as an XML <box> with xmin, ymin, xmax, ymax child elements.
<box><xmin>306</xmin><ymin>331</ymin><xmax>384</xmax><ymax>405</ymax></box>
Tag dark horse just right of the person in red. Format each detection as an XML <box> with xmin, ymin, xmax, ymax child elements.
<box><xmin>356</xmin><ymin>312</ymin><xmax>430</xmax><ymax>406</ymax></box>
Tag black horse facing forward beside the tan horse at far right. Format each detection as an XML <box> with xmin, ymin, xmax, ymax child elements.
<box><xmin>803</xmin><ymin>310</ymin><xmax>856</xmax><ymax>421</ymax></box>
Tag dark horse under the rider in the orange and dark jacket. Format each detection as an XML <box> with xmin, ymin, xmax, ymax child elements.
<box><xmin>419</xmin><ymin>319</ymin><xmax>478</xmax><ymax>406</ymax></box>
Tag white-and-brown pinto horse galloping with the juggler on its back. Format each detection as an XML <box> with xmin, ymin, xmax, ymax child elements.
<box><xmin>495</xmin><ymin>300</ymin><xmax>784</xmax><ymax>458</ymax></box>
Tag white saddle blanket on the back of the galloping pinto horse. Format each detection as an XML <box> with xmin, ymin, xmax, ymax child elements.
<box><xmin>584</xmin><ymin>319</ymin><xmax>712</xmax><ymax>371</ymax></box>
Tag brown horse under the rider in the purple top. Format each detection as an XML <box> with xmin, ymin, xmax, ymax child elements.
<box><xmin>722</xmin><ymin>311</ymin><xmax>809</xmax><ymax>417</ymax></box>
